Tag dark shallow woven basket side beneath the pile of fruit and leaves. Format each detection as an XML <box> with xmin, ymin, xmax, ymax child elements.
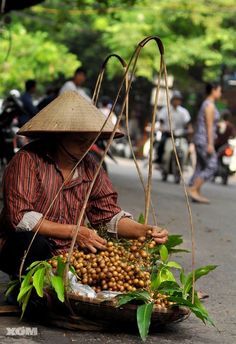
<box><xmin>42</xmin><ymin>293</ymin><xmax>190</xmax><ymax>330</ymax></box>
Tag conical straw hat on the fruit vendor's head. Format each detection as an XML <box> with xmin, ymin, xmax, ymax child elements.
<box><xmin>18</xmin><ymin>91</ymin><xmax>123</xmax><ymax>138</ymax></box>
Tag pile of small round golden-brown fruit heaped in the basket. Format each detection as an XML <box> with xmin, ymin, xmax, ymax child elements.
<box><xmin>49</xmin><ymin>233</ymin><xmax>172</xmax><ymax>309</ymax></box>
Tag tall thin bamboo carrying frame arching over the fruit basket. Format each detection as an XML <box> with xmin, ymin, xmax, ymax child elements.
<box><xmin>19</xmin><ymin>36</ymin><xmax>195</xmax><ymax>309</ymax></box>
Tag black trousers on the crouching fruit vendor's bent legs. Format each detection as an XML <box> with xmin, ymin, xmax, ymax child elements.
<box><xmin>0</xmin><ymin>232</ymin><xmax>52</xmax><ymax>276</ymax></box>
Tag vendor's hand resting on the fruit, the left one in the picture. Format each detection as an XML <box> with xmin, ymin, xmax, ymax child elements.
<box><xmin>76</xmin><ymin>227</ymin><xmax>107</xmax><ymax>253</ymax></box>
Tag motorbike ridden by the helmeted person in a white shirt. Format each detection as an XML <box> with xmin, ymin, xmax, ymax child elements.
<box><xmin>161</xmin><ymin>135</ymin><xmax>189</xmax><ymax>184</ymax></box>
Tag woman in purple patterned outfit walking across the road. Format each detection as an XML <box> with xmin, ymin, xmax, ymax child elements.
<box><xmin>188</xmin><ymin>83</ymin><xmax>221</xmax><ymax>204</ymax></box>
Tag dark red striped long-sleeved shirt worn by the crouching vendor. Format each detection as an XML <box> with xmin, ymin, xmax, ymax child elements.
<box><xmin>0</xmin><ymin>141</ymin><xmax>123</xmax><ymax>254</ymax></box>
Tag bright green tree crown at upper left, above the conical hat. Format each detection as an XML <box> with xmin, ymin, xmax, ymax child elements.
<box><xmin>0</xmin><ymin>23</ymin><xmax>80</xmax><ymax>94</ymax></box>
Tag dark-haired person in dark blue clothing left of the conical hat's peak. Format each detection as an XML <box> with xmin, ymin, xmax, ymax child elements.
<box><xmin>19</xmin><ymin>79</ymin><xmax>37</xmax><ymax>126</ymax></box>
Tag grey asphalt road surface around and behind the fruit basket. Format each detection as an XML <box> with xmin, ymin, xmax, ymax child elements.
<box><xmin>0</xmin><ymin>160</ymin><xmax>236</xmax><ymax>344</ymax></box>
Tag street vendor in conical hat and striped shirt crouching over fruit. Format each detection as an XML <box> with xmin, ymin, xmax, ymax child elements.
<box><xmin>0</xmin><ymin>91</ymin><xmax>168</xmax><ymax>275</ymax></box>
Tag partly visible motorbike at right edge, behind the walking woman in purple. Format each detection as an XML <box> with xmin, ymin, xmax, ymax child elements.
<box><xmin>214</xmin><ymin>138</ymin><xmax>236</xmax><ymax>185</ymax></box>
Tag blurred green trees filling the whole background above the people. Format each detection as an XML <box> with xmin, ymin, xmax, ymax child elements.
<box><xmin>0</xmin><ymin>0</ymin><xmax>236</xmax><ymax>140</ymax></box>
